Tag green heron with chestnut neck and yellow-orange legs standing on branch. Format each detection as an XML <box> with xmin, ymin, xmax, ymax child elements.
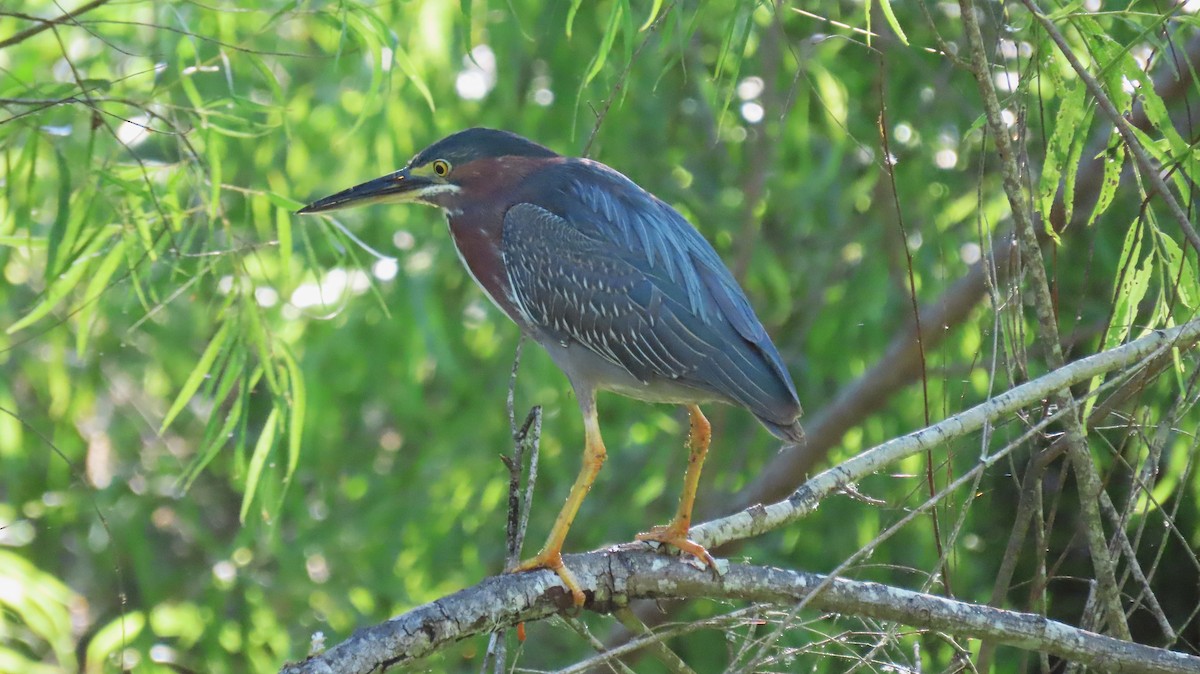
<box><xmin>299</xmin><ymin>128</ymin><xmax>804</xmax><ymax>606</ymax></box>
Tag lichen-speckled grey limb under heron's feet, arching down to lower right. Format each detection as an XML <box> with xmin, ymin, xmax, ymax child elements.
<box><xmin>281</xmin><ymin>549</ymin><xmax>1200</xmax><ymax>674</ymax></box>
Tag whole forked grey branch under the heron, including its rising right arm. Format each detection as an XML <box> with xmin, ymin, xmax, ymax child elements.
<box><xmin>281</xmin><ymin>319</ymin><xmax>1200</xmax><ymax>674</ymax></box>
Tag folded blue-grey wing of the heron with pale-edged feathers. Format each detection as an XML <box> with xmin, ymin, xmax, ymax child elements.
<box><xmin>502</xmin><ymin>196</ymin><xmax>800</xmax><ymax>440</ymax></box>
